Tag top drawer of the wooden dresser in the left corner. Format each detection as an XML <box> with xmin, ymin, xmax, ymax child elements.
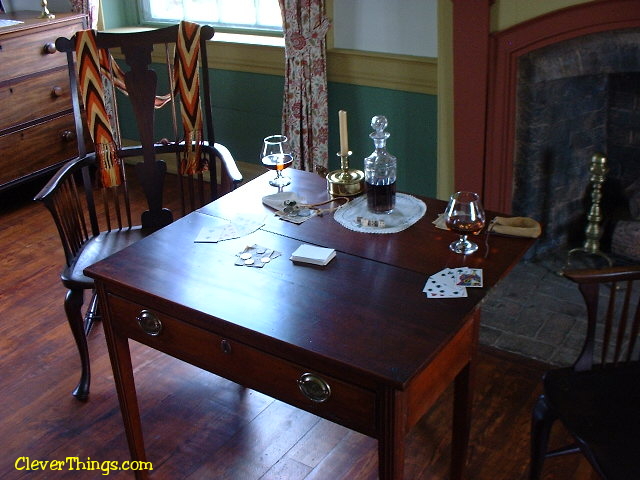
<box><xmin>0</xmin><ymin>22</ymin><xmax>82</xmax><ymax>83</ymax></box>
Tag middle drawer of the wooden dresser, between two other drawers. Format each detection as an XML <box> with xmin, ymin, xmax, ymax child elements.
<box><xmin>0</xmin><ymin>67</ymin><xmax>71</xmax><ymax>130</ymax></box>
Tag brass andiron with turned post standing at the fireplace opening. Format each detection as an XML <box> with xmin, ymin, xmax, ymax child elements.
<box><xmin>567</xmin><ymin>153</ymin><xmax>613</xmax><ymax>266</ymax></box>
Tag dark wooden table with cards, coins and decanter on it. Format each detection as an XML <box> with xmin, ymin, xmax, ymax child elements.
<box><xmin>86</xmin><ymin>170</ymin><xmax>532</xmax><ymax>479</ymax></box>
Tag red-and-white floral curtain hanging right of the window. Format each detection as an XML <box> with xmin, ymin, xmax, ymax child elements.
<box><xmin>278</xmin><ymin>0</ymin><xmax>329</xmax><ymax>174</ymax></box>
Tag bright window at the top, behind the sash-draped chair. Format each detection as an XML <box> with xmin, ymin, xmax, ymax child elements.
<box><xmin>139</xmin><ymin>0</ymin><xmax>282</xmax><ymax>33</ymax></box>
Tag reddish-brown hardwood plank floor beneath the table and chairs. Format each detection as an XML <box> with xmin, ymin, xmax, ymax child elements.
<box><xmin>0</xmin><ymin>174</ymin><xmax>596</xmax><ymax>480</ymax></box>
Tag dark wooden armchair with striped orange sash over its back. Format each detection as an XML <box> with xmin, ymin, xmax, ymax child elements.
<box><xmin>35</xmin><ymin>24</ymin><xmax>242</xmax><ymax>400</ymax></box>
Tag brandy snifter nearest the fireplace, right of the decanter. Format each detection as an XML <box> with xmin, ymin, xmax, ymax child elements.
<box><xmin>444</xmin><ymin>192</ymin><xmax>485</xmax><ymax>255</ymax></box>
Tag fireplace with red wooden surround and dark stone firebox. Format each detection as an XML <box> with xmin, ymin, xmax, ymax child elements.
<box><xmin>453</xmin><ymin>0</ymin><xmax>640</xmax><ymax>260</ymax></box>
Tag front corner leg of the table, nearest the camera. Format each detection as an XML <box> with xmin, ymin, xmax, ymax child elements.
<box><xmin>378</xmin><ymin>389</ymin><xmax>406</xmax><ymax>480</ymax></box>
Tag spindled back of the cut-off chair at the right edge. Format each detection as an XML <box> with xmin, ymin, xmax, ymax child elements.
<box><xmin>564</xmin><ymin>266</ymin><xmax>640</xmax><ymax>371</ymax></box>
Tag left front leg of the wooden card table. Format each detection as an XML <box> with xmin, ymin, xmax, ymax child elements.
<box><xmin>102</xmin><ymin>302</ymin><xmax>148</xmax><ymax>480</ymax></box>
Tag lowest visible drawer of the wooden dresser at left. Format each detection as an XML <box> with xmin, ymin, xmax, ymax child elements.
<box><xmin>0</xmin><ymin>113</ymin><xmax>78</xmax><ymax>184</ymax></box>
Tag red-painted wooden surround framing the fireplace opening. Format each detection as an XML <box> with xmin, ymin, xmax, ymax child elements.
<box><xmin>452</xmin><ymin>0</ymin><xmax>640</xmax><ymax>213</ymax></box>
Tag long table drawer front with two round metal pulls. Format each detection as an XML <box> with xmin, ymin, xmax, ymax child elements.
<box><xmin>108</xmin><ymin>295</ymin><xmax>376</xmax><ymax>437</ymax></box>
